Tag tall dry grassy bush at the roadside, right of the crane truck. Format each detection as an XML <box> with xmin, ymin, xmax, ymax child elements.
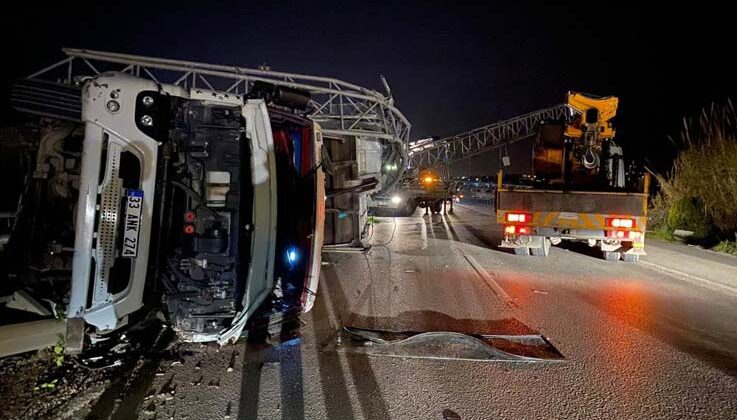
<box><xmin>651</xmin><ymin>102</ymin><xmax>737</xmax><ymax>242</ymax></box>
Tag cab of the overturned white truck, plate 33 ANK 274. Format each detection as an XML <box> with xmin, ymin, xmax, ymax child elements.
<box><xmin>68</xmin><ymin>72</ymin><xmax>325</xmax><ymax>344</ymax></box>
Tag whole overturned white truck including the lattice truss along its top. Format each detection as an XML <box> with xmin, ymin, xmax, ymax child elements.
<box><xmin>6</xmin><ymin>50</ymin><xmax>410</xmax><ymax>351</ymax></box>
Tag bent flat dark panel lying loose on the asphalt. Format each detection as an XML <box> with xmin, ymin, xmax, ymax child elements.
<box><xmin>323</xmin><ymin>327</ymin><xmax>565</xmax><ymax>362</ymax></box>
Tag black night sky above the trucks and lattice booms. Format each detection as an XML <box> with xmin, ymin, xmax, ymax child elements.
<box><xmin>0</xmin><ymin>0</ymin><xmax>737</xmax><ymax>169</ymax></box>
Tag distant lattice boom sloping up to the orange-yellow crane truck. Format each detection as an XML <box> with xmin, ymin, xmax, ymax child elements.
<box><xmin>409</xmin><ymin>105</ymin><xmax>578</xmax><ymax>168</ymax></box>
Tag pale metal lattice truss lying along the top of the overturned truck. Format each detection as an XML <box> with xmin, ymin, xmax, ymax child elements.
<box><xmin>23</xmin><ymin>49</ymin><xmax>411</xmax><ymax>147</ymax></box>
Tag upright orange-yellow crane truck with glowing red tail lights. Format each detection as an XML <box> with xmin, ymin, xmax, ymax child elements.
<box><xmin>496</xmin><ymin>92</ymin><xmax>650</xmax><ymax>262</ymax></box>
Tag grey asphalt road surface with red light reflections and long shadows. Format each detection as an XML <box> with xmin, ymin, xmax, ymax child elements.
<box><xmin>99</xmin><ymin>202</ymin><xmax>737</xmax><ymax>419</ymax></box>
